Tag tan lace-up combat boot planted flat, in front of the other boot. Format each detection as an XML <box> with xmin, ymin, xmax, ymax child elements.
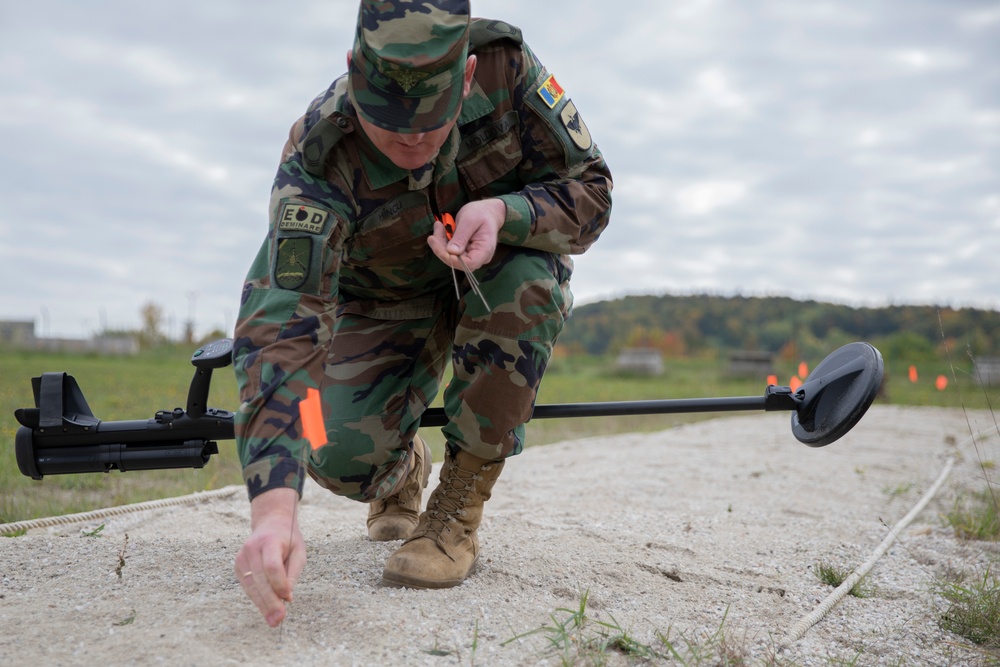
<box><xmin>382</xmin><ymin>450</ymin><xmax>504</xmax><ymax>588</ymax></box>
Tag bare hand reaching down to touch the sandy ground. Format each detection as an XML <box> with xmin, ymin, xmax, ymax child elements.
<box><xmin>233</xmin><ymin>489</ymin><xmax>306</xmax><ymax>628</ymax></box>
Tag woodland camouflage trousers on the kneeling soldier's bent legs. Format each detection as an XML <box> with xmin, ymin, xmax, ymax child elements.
<box><xmin>309</xmin><ymin>246</ymin><xmax>572</xmax><ymax>502</ymax></box>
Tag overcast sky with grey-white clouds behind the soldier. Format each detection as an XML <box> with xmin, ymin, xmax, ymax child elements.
<box><xmin>0</xmin><ymin>0</ymin><xmax>1000</xmax><ymax>337</ymax></box>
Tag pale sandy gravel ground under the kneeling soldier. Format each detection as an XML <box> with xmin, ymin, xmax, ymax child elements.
<box><xmin>0</xmin><ymin>405</ymin><xmax>1000</xmax><ymax>666</ymax></box>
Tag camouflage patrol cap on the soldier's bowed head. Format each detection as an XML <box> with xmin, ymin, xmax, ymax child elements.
<box><xmin>348</xmin><ymin>0</ymin><xmax>469</xmax><ymax>133</ymax></box>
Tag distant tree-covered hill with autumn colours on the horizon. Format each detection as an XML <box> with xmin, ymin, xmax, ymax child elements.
<box><xmin>559</xmin><ymin>294</ymin><xmax>1000</xmax><ymax>358</ymax></box>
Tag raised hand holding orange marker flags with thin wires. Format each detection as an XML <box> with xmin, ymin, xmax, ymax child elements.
<box><xmin>427</xmin><ymin>199</ymin><xmax>507</xmax><ymax>271</ymax></box>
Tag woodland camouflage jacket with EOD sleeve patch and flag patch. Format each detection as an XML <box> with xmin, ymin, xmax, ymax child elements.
<box><xmin>234</xmin><ymin>19</ymin><xmax>612</xmax><ymax>497</ymax></box>
